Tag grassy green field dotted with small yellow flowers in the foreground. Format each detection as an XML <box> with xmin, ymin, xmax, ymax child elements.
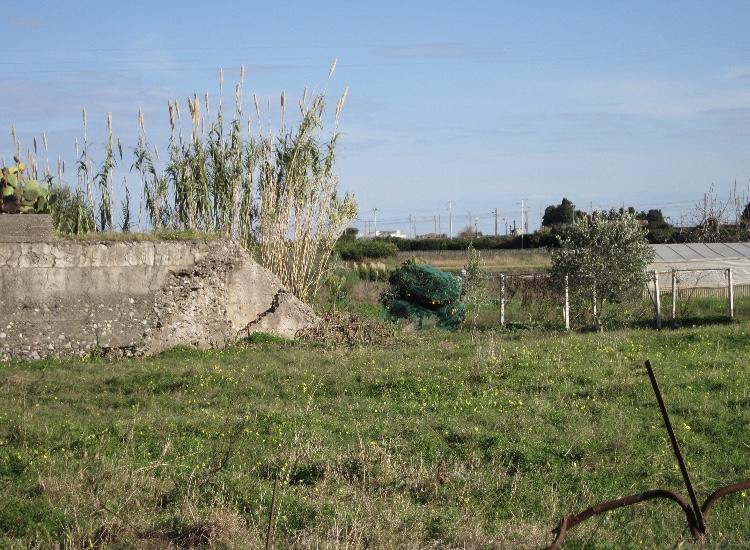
<box><xmin>0</xmin><ymin>323</ymin><xmax>750</xmax><ymax>548</ymax></box>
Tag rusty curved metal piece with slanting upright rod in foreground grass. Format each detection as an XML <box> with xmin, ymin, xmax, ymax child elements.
<box><xmin>547</xmin><ymin>361</ymin><xmax>750</xmax><ymax>550</ymax></box>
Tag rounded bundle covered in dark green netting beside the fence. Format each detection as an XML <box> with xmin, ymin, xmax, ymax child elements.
<box><xmin>380</xmin><ymin>260</ymin><xmax>466</xmax><ymax>330</ymax></box>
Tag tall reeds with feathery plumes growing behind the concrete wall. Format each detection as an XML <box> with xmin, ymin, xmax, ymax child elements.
<box><xmin>34</xmin><ymin>66</ymin><xmax>357</xmax><ymax>299</ymax></box>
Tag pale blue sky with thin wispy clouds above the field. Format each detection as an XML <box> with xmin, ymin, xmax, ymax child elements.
<box><xmin>0</xmin><ymin>1</ymin><xmax>750</xmax><ymax>233</ymax></box>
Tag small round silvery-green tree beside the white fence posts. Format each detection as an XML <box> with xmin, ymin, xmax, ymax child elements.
<box><xmin>552</xmin><ymin>210</ymin><xmax>654</xmax><ymax>331</ymax></box>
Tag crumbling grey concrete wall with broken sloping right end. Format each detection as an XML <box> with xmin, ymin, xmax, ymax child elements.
<box><xmin>0</xmin><ymin>240</ymin><xmax>317</xmax><ymax>360</ymax></box>
